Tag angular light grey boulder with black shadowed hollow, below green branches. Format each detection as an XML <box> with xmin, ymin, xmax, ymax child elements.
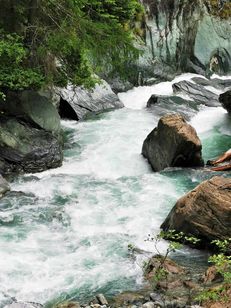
<box><xmin>56</xmin><ymin>80</ymin><xmax>124</xmax><ymax>120</ymax></box>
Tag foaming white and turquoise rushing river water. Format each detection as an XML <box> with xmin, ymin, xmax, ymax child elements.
<box><xmin>0</xmin><ymin>75</ymin><xmax>231</xmax><ymax>307</ymax></box>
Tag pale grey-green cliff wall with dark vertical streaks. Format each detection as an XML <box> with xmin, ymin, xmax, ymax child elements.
<box><xmin>138</xmin><ymin>0</ymin><xmax>231</xmax><ymax>79</ymax></box>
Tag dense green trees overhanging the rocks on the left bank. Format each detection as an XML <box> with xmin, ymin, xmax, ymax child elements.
<box><xmin>0</xmin><ymin>0</ymin><xmax>142</xmax><ymax>94</ymax></box>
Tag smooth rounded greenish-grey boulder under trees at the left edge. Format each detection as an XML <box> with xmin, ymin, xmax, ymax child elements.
<box><xmin>0</xmin><ymin>90</ymin><xmax>61</xmax><ymax>134</ymax></box>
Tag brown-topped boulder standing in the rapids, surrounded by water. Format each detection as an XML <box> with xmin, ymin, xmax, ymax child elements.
<box><xmin>142</xmin><ymin>114</ymin><xmax>204</xmax><ymax>171</ymax></box>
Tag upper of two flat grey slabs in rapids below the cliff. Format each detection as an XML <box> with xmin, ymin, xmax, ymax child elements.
<box><xmin>172</xmin><ymin>80</ymin><xmax>220</xmax><ymax>107</ymax></box>
